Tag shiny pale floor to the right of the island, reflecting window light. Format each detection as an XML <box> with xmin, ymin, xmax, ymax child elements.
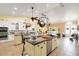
<box><xmin>49</xmin><ymin>38</ymin><xmax>79</xmax><ymax>56</ymax></box>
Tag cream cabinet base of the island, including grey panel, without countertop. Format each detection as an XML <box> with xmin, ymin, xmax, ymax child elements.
<box><xmin>25</xmin><ymin>39</ymin><xmax>57</xmax><ymax>56</ymax></box>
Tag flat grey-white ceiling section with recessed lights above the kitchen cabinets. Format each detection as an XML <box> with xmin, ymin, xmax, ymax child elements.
<box><xmin>0</xmin><ymin>3</ymin><xmax>57</xmax><ymax>16</ymax></box>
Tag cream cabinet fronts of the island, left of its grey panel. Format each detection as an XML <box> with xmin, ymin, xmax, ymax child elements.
<box><xmin>25</xmin><ymin>42</ymin><xmax>47</xmax><ymax>56</ymax></box>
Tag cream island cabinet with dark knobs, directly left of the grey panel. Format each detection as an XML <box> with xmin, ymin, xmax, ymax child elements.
<box><xmin>35</xmin><ymin>42</ymin><xmax>47</xmax><ymax>56</ymax></box>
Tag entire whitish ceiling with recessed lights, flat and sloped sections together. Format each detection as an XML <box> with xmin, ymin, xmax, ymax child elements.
<box><xmin>0</xmin><ymin>3</ymin><xmax>79</xmax><ymax>22</ymax></box>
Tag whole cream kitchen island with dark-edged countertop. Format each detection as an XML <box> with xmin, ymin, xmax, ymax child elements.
<box><xmin>24</xmin><ymin>35</ymin><xmax>57</xmax><ymax>56</ymax></box>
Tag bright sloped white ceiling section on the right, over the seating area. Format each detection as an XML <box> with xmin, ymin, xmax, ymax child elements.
<box><xmin>48</xmin><ymin>3</ymin><xmax>79</xmax><ymax>23</ymax></box>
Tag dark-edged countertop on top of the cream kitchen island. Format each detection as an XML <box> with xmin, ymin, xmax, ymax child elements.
<box><xmin>25</xmin><ymin>36</ymin><xmax>53</xmax><ymax>45</ymax></box>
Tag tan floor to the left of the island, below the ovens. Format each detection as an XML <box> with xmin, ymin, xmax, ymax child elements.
<box><xmin>0</xmin><ymin>42</ymin><xmax>22</xmax><ymax>56</ymax></box>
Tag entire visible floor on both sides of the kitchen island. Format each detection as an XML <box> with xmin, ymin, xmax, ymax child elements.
<box><xmin>0</xmin><ymin>38</ymin><xmax>79</xmax><ymax>56</ymax></box>
